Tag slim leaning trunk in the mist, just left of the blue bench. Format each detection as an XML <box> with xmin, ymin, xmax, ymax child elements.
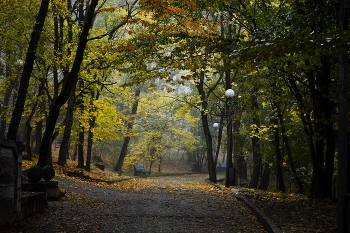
<box><xmin>114</xmin><ymin>88</ymin><xmax>141</xmax><ymax>175</ymax></box>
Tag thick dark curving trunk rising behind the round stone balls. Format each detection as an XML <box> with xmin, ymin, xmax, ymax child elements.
<box><xmin>38</xmin><ymin>0</ymin><xmax>98</xmax><ymax>167</ymax></box>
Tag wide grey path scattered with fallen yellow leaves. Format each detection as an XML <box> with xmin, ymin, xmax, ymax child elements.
<box><xmin>3</xmin><ymin>174</ymin><xmax>266</xmax><ymax>233</ymax></box>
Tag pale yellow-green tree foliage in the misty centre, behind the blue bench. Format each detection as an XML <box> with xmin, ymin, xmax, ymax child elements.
<box><xmin>128</xmin><ymin>91</ymin><xmax>198</xmax><ymax>164</ymax></box>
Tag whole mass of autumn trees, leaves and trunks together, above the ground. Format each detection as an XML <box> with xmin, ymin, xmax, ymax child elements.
<box><xmin>0</xmin><ymin>0</ymin><xmax>349</xmax><ymax>198</ymax></box>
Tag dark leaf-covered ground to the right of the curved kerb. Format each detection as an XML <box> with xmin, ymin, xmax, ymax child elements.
<box><xmin>235</xmin><ymin>189</ymin><xmax>337</xmax><ymax>233</ymax></box>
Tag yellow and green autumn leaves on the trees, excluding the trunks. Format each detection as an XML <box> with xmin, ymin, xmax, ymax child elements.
<box><xmin>0</xmin><ymin>0</ymin><xmax>349</xmax><ymax>197</ymax></box>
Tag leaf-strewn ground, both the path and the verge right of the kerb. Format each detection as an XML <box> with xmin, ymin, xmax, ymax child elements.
<box><xmin>0</xmin><ymin>159</ymin><xmax>336</xmax><ymax>233</ymax></box>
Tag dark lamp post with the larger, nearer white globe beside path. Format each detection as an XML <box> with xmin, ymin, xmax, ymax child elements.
<box><xmin>225</xmin><ymin>89</ymin><xmax>235</xmax><ymax>187</ymax></box>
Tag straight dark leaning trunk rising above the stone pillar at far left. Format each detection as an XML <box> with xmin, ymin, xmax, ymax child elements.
<box><xmin>6</xmin><ymin>0</ymin><xmax>50</xmax><ymax>140</ymax></box>
